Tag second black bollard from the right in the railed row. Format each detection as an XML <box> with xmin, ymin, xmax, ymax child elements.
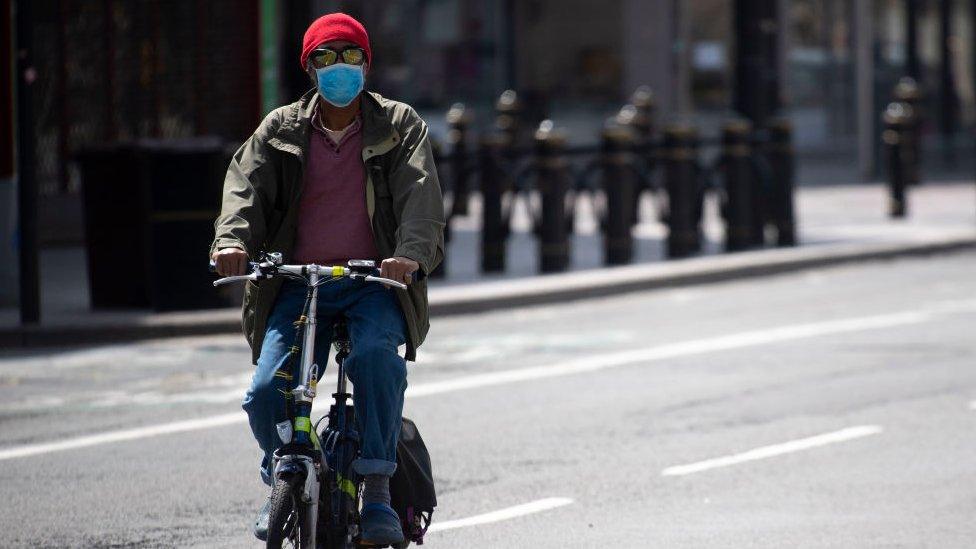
<box><xmin>722</xmin><ymin>120</ymin><xmax>762</xmax><ymax>252</ymax></box>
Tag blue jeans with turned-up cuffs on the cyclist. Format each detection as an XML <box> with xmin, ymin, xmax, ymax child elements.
<box><xmin>243</xmin><ymin>278</ymin><xmax>407</xmax><ymax>485</ymax></box>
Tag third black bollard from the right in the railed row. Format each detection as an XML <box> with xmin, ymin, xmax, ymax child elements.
<box><xmin>663</xmin><ymin>124</ymin><xmax>701</xmax><ymax>257</ymax></box>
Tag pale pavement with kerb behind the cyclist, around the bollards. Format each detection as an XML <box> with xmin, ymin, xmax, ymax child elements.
<box><xmin>0</xmin><ymin>183</ymin><xmax>976</xmax><ymax>346</ymax></box>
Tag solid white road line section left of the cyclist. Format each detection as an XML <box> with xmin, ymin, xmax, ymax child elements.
<box><xmin>0</xmin><ymin>412</ymin><xmax>247</xmax><ymax>460</ymax></box>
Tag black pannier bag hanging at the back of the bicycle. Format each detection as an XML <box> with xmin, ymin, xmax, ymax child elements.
<box><xmin>390</xmin><ymin>418</ymin><xmax>437</xmax><ymax>545</ymax></box>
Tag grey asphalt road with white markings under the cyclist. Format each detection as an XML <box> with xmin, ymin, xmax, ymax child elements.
<box><xmin>0</xmin><ymin>254</ymin><xmax>976</xmax><ymax>548</ymax></box>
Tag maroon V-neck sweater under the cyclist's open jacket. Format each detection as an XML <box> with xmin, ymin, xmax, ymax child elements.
<box><xmin>293</xmin><ymin>113</ymin><xmax>381</xmax><ymax>265</ymax></box>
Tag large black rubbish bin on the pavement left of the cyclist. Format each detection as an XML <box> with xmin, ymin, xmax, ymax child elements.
<box><xmin>79</xmin><ymin>138</ymin><xmax>230</xmax><ymax>311</ymax></box>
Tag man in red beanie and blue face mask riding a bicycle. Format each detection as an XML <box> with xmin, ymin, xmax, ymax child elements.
<box><xmin>211</xmin><ymin>13</ymin><xmax>444</xmax><ymax>545</ymax></box>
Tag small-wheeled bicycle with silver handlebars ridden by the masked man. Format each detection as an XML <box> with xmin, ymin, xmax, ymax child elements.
<box><xmin>211</xmin><ymin>253</ymin><xmax>420</xmax><ymax>549</ymax></box>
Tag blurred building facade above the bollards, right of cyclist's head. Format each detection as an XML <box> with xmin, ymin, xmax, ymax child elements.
<box><xmin>311</xmin><ymin>0</ymin><xmax>976</xmax><ymax>181</ymax></box>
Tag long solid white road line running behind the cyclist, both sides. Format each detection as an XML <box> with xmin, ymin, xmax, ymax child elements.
<box><xmin>0</xmin><ymin>311</ymin><xmax>934</xmax><ymax>461</ymax></box>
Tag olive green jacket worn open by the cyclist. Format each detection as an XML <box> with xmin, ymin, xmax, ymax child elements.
<box><xmin>210</xmin><ymin>90</ymin><xmax>444</xmax><ymax>363</ymax></box>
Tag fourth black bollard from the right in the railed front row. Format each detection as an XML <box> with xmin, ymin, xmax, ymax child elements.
<box><xmin>601</xmin><ymin>119</ymin><xmax>640</xmax><ymax>265</ymax></box>
